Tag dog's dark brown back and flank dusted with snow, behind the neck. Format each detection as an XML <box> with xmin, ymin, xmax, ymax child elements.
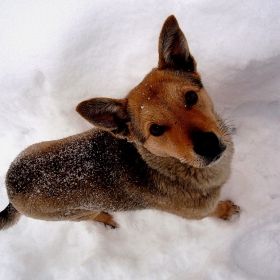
<box><xmin>6</xmin><ymin>129</ymin><xmax>153</xmax><ymax>220</ymax></box>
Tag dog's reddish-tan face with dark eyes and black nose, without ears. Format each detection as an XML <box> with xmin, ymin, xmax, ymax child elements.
<box><xmin>127</xmin><ymin>69</ymin><xmax>230</xmax><ymax>167</ymax></box>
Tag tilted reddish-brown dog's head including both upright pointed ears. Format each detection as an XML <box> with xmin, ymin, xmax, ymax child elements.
<box><xmin>77</xmin><ymin>16</ymin><xmax>230</xmax><ymax>168</ymax></box>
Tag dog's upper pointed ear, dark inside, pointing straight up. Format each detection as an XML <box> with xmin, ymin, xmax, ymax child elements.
<box><xmin>158</xmin><ymin>15</ymin><xmax>196</xmax><ymax>72</ymax></box>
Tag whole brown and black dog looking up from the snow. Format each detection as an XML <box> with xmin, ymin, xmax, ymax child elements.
<box><xmin>0</xmin><ymin>15</ymin><xmax>240</xmax><ymax>229</ymax></box>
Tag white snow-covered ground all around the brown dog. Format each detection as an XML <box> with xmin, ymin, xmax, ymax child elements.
<box><xmin>0</xmin><ymin>0</ymin><xmax>280</xmax><ymax>280</ymax></box>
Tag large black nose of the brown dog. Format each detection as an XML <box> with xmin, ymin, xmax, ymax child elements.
<box><xmin>192</xmin><ymin>131</ymin><xmax>226</xmax><ymax>163</ymax></box>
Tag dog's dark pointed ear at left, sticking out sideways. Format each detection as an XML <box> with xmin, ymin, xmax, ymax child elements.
<box><xmin>76</xmin><ymin>98</ymin><xmax>129</xmax><ymax>136</ymax></box>
